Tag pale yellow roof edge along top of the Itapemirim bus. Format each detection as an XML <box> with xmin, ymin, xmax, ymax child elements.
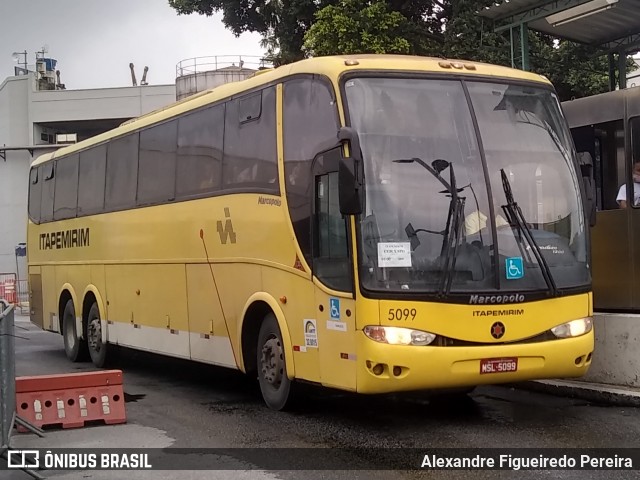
<box><xmin>32</xmin><ymin>54</ymin><xmax>551</xmax><ymax>165</ymax></box>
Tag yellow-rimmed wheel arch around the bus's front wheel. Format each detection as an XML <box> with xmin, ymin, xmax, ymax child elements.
<box><xmin>236</xmin><ymin>292</ymin><xmax>295</xmax><ymax>379</ymax></box>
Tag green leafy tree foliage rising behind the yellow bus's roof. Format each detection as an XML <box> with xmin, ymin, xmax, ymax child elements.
<box><xmin>169</xmin><ymin>0</ymin><xmax>633</xmax><ymax>100</ymax></box>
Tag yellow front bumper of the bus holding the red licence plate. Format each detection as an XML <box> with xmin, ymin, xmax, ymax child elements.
<box><xmin>356</xmin><ymin>330</ymin><xmax>594</xmax><ymax>393</ymax></box>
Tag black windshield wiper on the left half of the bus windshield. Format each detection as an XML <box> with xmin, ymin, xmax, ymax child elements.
<box><xmin>393</xmin><ymin>157</ymin><xmax>465</xmax><ymax>296</ymax></box>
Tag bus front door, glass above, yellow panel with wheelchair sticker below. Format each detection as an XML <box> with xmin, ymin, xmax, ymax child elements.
<box><xmin>312</xmin><ymin>147</ymin><xmax>356</xmax><ymax>390</ymax></box>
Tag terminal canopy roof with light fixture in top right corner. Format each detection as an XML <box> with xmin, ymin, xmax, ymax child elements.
<box><xmin>479</xmin><ymin>0</ymin><xmax>640</xmax><ymax>53</ymax></box>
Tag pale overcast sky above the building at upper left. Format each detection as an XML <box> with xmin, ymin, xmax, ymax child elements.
<box><xmin>0</xmin><ymin>0</ymin><xmax>264</xmax><ymax>89</ymax></box>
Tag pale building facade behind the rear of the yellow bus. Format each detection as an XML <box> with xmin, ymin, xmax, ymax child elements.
<box><xmin>0</xmin><ymin>71</ymin><xmax>176</xmax><ymax>279</ymax></box>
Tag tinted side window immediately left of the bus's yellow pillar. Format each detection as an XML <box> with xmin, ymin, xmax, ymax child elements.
<box><xmin>222</xmin><ymin>87</ymin><xmax>280</xmax><ymax>194</ymax></box>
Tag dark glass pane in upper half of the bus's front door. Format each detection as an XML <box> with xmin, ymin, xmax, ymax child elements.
<box><xmin>313</xmin><ymin>150</ymin><xmax>352</xmax><ymax>291</ymax></box>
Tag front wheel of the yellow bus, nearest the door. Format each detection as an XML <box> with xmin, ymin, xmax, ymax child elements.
<box><xmin>257</xmin><ymin>313</ymin><xmax>292</xmax><ymax>410</ymax></box>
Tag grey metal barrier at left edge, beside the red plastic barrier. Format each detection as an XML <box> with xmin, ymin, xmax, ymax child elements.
<box><xmin>0</xmin><ymin>300</ymin><xmax>44</xmax><ymax>479</ymax></box>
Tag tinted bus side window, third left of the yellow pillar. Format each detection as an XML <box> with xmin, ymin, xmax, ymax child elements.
<box><xmin>138</xmin><ymin>120</ymin><xmax>178</xmax><ymax>205</ymax></box>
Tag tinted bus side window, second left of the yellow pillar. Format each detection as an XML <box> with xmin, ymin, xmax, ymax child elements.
<box><xmin>176</xmin><ymin>105</ymin><xmax>224</xmax><ymax>197</ymax></box>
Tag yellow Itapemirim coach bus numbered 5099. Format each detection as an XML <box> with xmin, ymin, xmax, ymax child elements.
<box><xmin>28</xmin><ymin>55</ymin><xmax>594</xmax><ymax>409</ymax></box>
